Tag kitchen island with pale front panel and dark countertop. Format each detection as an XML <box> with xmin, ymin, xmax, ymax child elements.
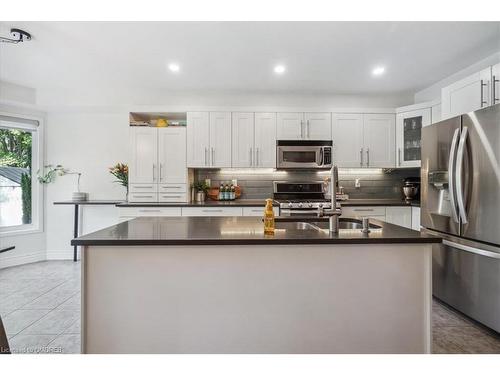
<box><xmin>72</xmin><ymin>217</ymin><xmax>441</xmax><ymax>353</ymax></box>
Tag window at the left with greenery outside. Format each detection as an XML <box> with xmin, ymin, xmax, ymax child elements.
<box><xmin>0</xmin><ymin>115</ymin><xmax>40</xmax><ymax>232</ymax></box>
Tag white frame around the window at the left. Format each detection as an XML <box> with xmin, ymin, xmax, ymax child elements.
<box><xmin>0</xmin><ymin>111</ymin><xmax>44</xmax><ymax>237</ymax></box>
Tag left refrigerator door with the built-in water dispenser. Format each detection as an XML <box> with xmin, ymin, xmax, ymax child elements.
<box><xmin>420</xmin><ymin>117</ymin><xmax>461</xmax><ymax>235</ymax></box>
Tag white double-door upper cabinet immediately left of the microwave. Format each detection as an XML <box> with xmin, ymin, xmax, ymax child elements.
<box><xmin>232</xmin><ymin>112</ymin><xmax>276</xmax><ymax>168</ymax></box>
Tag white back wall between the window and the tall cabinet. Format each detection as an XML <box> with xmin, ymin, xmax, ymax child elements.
<box><xmin>45</xmin><ymin>112</ymin><xmax>129</xmax><ymax>259</ymax></box>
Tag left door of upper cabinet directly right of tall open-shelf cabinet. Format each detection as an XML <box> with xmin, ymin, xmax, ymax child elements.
<box><xmin>186</xmin><ymin>112</ymin><xmax>210</xmax><ymax>168</ymax></box>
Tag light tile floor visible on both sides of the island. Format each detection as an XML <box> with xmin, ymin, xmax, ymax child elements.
<box><xmin>0</xmin><ymin>261</ymin><xmax>500</xmax><ymax>354</ymax></box>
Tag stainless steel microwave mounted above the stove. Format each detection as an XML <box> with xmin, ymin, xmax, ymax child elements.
<box><xmin>276</xmin><ymin>141</ymin><xmax>333</xmax><ymax>169</ymax></box>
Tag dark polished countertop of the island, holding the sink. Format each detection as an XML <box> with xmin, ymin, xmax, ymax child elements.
<box><xmin>71</xmin><ymin>217</ymin><xmax>441</xmax><ymax>246</ymax></box>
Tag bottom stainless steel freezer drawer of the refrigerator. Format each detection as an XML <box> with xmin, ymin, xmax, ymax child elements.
<box><xmin>429</xmin><ymin>232</ymin><xmax>500</xmax><ymax>332</ymax></box>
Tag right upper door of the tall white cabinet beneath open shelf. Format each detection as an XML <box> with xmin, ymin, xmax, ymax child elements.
<box><xmin>158</xmin><ymin>127</ymin><xmax>187</xmax><ymax>184</ymax></box>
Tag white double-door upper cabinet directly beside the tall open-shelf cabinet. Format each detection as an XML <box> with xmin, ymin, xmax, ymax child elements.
<box><xmin>187</xmin><ymin>112</ymin><xmax>231</xmax><ymax>168</ymax></box>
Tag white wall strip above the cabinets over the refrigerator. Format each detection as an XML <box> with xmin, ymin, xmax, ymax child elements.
<box><xmin>414</xmin><ymin>52</ymin><xmax>500</xmax><ymax>103</ymax></box>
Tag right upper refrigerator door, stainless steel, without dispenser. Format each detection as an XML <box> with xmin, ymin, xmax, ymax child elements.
<box><xmin>456</xmin><ymin>104</ymin><xmax>500</xmax><ymax>245</ymax></box>
